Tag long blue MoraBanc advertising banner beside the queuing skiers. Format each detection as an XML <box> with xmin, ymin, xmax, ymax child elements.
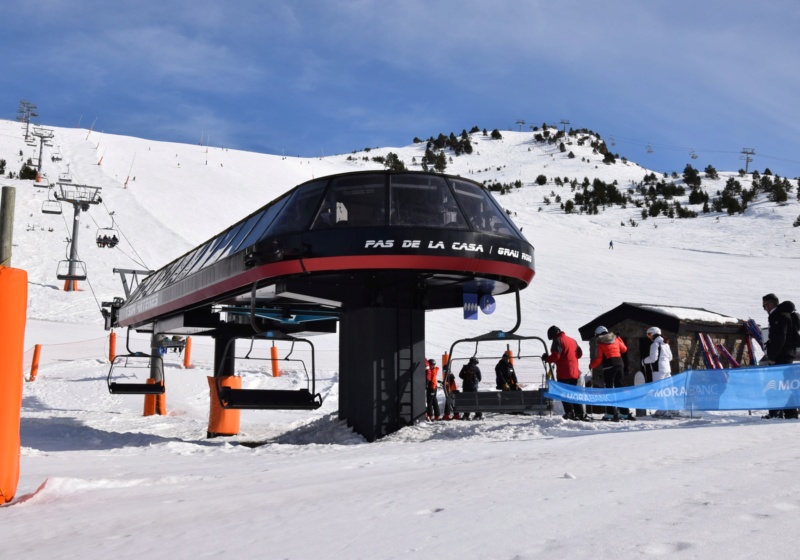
<box><xmin>545</xmin><ymin>364</ymin><xmax>800</xmax><ymax>410</ymax></box>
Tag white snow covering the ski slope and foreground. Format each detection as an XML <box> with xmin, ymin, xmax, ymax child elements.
<box><xmin>0</xmin><ymin>121</ymin><xmax>800</xmax><ymax>559</ymax></box>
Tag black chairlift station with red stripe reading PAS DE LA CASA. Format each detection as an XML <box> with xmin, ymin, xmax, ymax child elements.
<box><xmin>103</xmin><ymin>171</ymin><xmax>542</xmax><ymax>441</ymax></box>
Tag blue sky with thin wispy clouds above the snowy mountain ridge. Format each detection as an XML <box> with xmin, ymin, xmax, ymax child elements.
<box><xmin>6</xmin><ymin>0</ymin><xmax>800</xmax><ymax>177</ymax></box>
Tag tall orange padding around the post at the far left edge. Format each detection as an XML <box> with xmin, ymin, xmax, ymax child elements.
<box><xmin>0</xmin><ymin>266</ymin><xmax>28</xmax><ymax>504</ymax></box>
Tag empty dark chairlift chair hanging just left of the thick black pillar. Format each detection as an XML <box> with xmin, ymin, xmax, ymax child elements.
<box><xmin>214</xmin><ymin>332</ymin><xmax>322</xmax><ymax>410</ymax></box>
